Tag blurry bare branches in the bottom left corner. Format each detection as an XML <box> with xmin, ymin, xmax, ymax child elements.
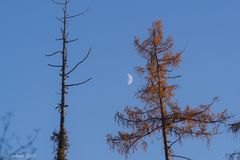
<box><xmin>0</xmin><ymin>113</ymin><xmax>38</xmax><ymax>160</ymax></box>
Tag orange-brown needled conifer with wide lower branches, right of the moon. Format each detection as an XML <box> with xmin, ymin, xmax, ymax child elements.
<box><xmin>107</xmin><ymin>21</ymin><xmax>228</xmax><ymax>160</ymax></box>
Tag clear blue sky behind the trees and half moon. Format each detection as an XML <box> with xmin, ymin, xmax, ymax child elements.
<box><xmin>0</xmin><ymin>0</ymin><xmax>240</xmax><ymax>160</ymax></box>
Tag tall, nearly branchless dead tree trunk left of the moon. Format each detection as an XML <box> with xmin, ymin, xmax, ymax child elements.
<box><xmin>47</xmin><ymin>0</ymin><xmax>91</xmax><ymax>160</ymax></box>
